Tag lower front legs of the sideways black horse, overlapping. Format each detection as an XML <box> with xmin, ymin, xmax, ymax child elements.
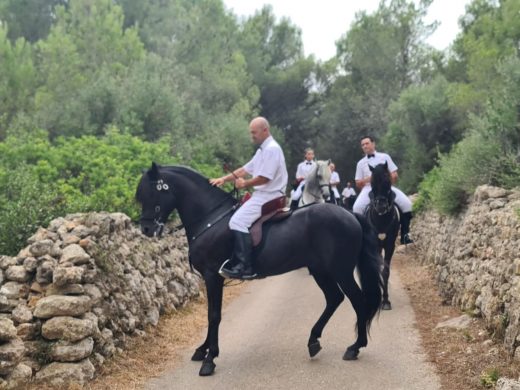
<box><xmin>192</xmin><ymin>272</ymin><xmax>224</xmax><ymax>376</ymax></box>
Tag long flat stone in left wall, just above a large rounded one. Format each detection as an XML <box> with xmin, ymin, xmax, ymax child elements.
<box><xmin>33</xmin><ymin>295</ymin><xmax>91</xmax><ymax>318</ymax></box>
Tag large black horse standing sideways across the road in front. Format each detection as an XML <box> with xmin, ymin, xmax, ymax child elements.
<box><xmin>136</xmin><ymin>163</ymin><xmax>382</xmax><ymax>376</ymax></box>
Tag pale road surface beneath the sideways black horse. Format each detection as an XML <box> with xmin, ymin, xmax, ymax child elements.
<box><xmin>145</xmin><ymin>269</ymin><xmax>440</xmax><ymax>390</ymax></box>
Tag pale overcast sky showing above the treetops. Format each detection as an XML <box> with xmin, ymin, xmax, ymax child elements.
<box><xmin>224</xmin><ymin>0</ymin><xmax>470</xmax><ymax>60</ymax></box>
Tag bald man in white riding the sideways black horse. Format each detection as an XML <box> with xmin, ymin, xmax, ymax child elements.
<box><xmin>210</xmin><ymin>117</ymin><xmax>288</xmax><ymax>279</ymax></box>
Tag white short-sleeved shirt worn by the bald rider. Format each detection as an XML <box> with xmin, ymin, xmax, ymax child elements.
<box><xmin>244</xmin><ymin>136</ymin><xmax>288</xmax><ymax>194</ymax></box>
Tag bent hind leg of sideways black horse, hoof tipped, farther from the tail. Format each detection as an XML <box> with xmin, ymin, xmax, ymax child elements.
<box><xmin>307</xmin><ymin>270</ymin><xmax>345</xmax><ymax>357</ymax></box>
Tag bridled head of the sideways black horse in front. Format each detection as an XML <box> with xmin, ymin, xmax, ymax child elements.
<box><xmin>135</xmin><ymin>163</ymin><xmax>175</xmax><ymax>237</ymax></box>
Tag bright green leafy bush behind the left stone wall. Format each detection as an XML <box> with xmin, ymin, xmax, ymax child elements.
<box><xmin>0</xmin><ymin>128</ymin><xmax>222</xmax><ymax>255</ymax></box>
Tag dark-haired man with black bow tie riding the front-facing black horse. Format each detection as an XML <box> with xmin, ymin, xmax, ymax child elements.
<box><xmin>353</xmin><ymin>136</ymin><xmax>413</xmax><ymax>244</ymax></box>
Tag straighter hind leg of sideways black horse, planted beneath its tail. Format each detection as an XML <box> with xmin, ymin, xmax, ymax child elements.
<box><xmin>338</xmin><ymin>273</ymin><xmax>368</xmax><ymax>360</ymax></box>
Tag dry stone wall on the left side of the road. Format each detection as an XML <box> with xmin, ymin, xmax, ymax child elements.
<box><xmin>0</xmin><ymin>213</ymin><xmax>200</xmax><ymax>388</ymax></box>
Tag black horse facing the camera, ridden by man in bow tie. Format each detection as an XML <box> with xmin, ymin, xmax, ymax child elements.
<box><xmin>365</xmin><ymin>162</ymin><xmax>399</xmax><ymax>310</ymax></box>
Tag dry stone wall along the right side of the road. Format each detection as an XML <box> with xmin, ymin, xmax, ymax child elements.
<box><xmin>413</xmin><ymin>186</ymin><xmax>520</xmax><ymax>360</ymax></box>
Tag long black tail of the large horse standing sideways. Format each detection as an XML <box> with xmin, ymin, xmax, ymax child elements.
<box><xmin>354</xmin><ymin>213</ymin><xmax>383</xmax><ymax>331</ymax></box>
